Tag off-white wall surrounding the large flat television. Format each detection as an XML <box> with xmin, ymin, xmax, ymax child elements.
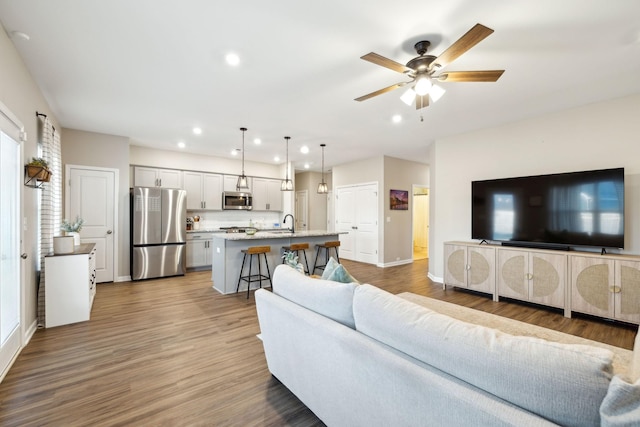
<box><xmin>429</xmin><ymin>95</ymin><xmax>640</xmax><ymax>280</ymax></box>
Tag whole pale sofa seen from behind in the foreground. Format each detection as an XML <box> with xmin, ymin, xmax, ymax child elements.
<box><xmin>255</xmin><ymin>265</ymin><xmax>640</xmax><ymax>427</ymax></box>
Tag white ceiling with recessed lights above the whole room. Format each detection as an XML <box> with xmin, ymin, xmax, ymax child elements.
<box><xmin>0</xmin><ymin>0</ymin><xmax>640</xmax><ymax>170</ymax></box>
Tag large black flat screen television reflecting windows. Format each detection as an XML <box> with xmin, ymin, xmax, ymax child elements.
<box><xmin>471</xmin><ymin>168</ymin><xmax>624</xmax><ymax>250</ymax></box>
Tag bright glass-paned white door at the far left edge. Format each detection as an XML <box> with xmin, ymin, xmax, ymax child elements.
<box><xmin>0</xmin><ymin>108</ymin><xmax>23</xmax><ymax>381</ymax></box>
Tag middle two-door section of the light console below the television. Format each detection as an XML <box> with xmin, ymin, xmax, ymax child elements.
<box><xmin>497</xmin><ymin>248</ymin><xmax>567</xmax><ymax>308</ymax></box>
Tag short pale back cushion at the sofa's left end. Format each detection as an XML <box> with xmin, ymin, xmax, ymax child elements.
<box><xmin>273</xmin><ymin>264</ymin><xmax>358</xmax><ymax>329</ymax></box>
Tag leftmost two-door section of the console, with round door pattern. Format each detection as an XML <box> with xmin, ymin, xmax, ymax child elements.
<box><xmin>444</xmin><ymin>243</ymin><xmax>496</xmax><ymax>296</ymax></box>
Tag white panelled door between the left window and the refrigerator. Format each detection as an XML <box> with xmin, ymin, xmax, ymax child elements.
<box><xmin>65</xmin><ymin>165</ymin><xmax>118</xmax><ymax>283</ymax></box>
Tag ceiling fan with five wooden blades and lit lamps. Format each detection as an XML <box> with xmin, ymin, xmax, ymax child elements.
<box><xmin>355</xmin><ymin>24</ymin><xmax>504</xmax><ymax>110</ymax></box>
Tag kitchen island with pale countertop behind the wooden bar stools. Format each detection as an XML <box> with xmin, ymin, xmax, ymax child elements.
<box><xmin>211</xmin><ymin>230</ymin><xmax>344</xmax><ymax>294</ymax></box>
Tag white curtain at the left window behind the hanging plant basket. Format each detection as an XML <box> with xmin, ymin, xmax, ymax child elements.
<box><xmin>38</xmin><ymin>115</ymin><xmax>62</xmax><ymax>326</ymax></box>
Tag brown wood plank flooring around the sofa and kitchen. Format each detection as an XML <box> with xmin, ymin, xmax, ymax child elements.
<box><xmin>0</xmin><ymin>260</ymin><xmax>637</xmax><ymax>426</ymax></box>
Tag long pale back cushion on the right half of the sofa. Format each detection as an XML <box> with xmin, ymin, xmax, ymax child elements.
<box><xmin>353</xmin><ymin>285</ymin><xmax>613</xmax><ymax>426</ymax></box>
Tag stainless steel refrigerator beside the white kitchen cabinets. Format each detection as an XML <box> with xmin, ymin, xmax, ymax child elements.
<box><xmin>131</xmin><ymin>187</ymin><xmax>187</xmax><ymax>280</ymax></box>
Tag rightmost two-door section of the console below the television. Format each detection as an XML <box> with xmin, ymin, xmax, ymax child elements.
<box><xmin>570</xmin><ymin>255</ymin><xmax>640</xmax><ymax>323</ymax></box>
